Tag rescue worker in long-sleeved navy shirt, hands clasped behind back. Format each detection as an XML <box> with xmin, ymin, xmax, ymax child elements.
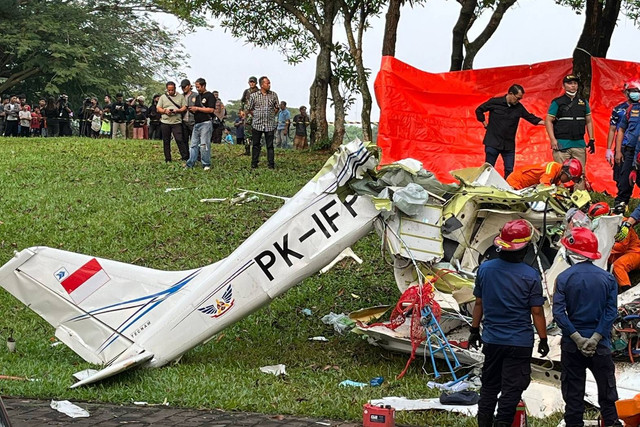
<box><xmin>553</xmin><ymin>227</ymin><xmax>621</xmax><ymax>427</ymax></box>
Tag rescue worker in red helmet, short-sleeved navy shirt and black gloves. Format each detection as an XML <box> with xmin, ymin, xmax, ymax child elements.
<box><xmin>469</xmin><ymin>219</ymin><xmax>549</xmax><ymax>427</ymax></box>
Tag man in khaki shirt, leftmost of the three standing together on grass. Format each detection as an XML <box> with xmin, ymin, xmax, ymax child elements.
<box><xmin>156</xmin><ymin>81</ymin><xmax>189</xmax><ymax>163</ymax></box>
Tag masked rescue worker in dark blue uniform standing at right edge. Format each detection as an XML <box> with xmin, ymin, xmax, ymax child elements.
<box><xmin>613</xmin><ymin>80</ymin><xmax>640</xmax><ymax>214</ymax></box>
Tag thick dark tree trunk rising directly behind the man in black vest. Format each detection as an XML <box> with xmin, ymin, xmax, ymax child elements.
<box><xmin>573</xmin><ymin>0</ymin><xmax>622</xmax><ymax>99</ymax></box>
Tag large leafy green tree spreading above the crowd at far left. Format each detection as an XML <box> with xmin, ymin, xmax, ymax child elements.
<box><xmin>0</xmin><ymin>0</ymin><xmax>200</xmax><ymax>99</ymax></box>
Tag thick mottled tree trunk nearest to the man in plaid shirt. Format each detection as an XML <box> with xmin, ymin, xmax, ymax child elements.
<box><xmin>309</xmin><ymin>45</ymin><xmax>331</xmax><ymax>146</ymax></box>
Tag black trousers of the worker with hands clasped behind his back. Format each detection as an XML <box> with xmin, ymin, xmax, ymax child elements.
<box><xmin>560</xmin><ymin>343</ymin><xmax>618</xmax><ymax>427</ymax></box>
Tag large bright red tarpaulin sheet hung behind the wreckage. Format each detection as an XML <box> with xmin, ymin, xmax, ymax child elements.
<box><xmin>375</xmin><ymin>56</ymin><xmax>640</xmax><ymax>194</ymax></box>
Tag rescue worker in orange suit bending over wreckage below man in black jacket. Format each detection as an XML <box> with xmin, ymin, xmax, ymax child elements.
<box><xmin>507</xmin><ymin>159</ymin><xmax>582</xmax><ymax>190</ymax></box>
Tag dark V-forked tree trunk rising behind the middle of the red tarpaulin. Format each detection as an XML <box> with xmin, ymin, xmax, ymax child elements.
<box><xmin>450</xmin><ymin>0</ymin><xmax>517</xmax><ymax>71</ymax></box>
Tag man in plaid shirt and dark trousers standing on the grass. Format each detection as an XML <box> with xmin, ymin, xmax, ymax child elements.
<box><xmin>248</xmin><ymin>76</ymin><xmax>280</xmax><ymax>169</ymax></box>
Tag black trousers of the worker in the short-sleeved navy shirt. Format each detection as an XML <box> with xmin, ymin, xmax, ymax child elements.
<box><xmin>478</xmin><ymin>343</ymin><xmax>533</xmax><ymax>425</ymax></box>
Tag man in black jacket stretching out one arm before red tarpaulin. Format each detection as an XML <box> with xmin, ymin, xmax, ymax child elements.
<box><xmin>476</xmin><ymin>84</ymin><xmax>544</xmax><ymax>179</ymax></box>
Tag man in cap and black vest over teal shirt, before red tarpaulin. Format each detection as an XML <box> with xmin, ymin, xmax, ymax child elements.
<box><xmin>544</xmin><ymin>74</ymin><xmax>596</xmax><ymax>190</ymax></box>
